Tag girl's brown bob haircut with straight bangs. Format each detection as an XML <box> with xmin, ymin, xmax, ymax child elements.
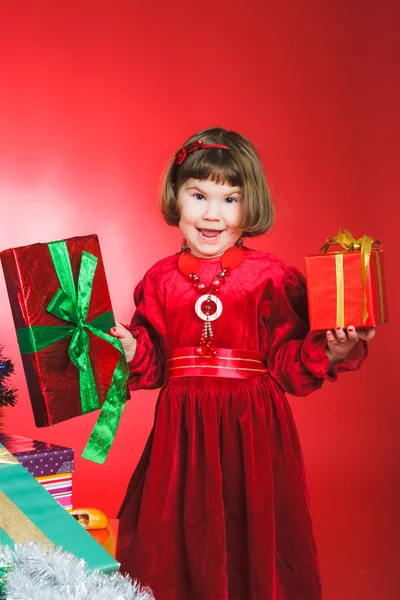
<box><xmin>161</xmin><ymin>128</ymin><xmax>274</xmax><ymax>236</ymax></box>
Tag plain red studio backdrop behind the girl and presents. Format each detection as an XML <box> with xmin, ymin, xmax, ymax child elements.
<box><xmin>0</xmin><ymin>0</ymin><xmax>400</xmax><ymax>600</ymax></box>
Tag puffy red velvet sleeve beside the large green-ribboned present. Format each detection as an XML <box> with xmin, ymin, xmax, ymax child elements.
<box><xmin>128</xmin><ymin>278</ymin><xmax>165</xmax><ymax>390</ymax></box>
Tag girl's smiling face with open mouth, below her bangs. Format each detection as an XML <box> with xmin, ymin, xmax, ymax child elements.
<box><xmin>178</xmin><ymin>179</ymin><xmax>243</xmax><ymax>258</ymax></box>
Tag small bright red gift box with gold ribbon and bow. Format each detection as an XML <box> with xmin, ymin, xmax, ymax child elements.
<box><xmin>305</xmin><ymin>229</ymin><xmax>388</xmax><ymax>330</ymax></box>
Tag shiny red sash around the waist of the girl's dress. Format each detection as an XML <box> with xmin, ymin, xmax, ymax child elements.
<box><xmin>165</xmin><ymin>348</ymin><xmax>268</xmax><ymax>379</ymax></box>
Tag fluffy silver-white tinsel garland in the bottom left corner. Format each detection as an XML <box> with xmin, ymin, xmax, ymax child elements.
<box><xmin>0</xmin><ymin>544</ymin><xmax>155</xmax><ymax>600</ymax></box>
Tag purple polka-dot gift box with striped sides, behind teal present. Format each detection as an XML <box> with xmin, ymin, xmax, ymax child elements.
<box><xmin>0</xmin><ymin>432</ymin><xmax>74</xmax><ymax>510</ymax></box>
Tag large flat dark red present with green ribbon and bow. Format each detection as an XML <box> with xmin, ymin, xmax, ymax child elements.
<box><xmin>0</xmin><ymin>235</ymin><xmax>128</xmax><ymax>462</ymax></box>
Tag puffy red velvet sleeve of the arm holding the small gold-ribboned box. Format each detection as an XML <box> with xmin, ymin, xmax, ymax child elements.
<box><xmin>263</xmin><ymin>267</ymin><xmax>367</xmax><ymax>396</ymax></box>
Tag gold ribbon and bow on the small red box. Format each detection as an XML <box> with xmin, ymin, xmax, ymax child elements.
<box><xmin>319</xmin><ymin>227</ymin><xmax>381</xmax><ymax>327</ymax></box>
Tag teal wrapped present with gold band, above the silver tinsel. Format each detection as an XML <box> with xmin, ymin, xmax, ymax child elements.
<box><xmin>0</xmin><ymin>444</ymin><xmax>119</xmax><ymax>573</ymax></box>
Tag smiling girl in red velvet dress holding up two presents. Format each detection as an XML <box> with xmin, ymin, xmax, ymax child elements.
<box><xmin>112</xmin><ymin>129</ymin><xmax>374</xmax><ymax>600</ymax></box>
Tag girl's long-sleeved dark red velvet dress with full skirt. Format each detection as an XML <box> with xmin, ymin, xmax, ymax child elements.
<box><xmin>118</xmin><ymin>249</ymin><xmax>366</xmax><ymax>600</ymax></box>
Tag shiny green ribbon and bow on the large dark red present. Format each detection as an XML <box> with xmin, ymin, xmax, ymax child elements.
<box><xmin>17</xmin><ymin>241</ymin><xmax>128</xmax><ymax>464</ymax></box>
